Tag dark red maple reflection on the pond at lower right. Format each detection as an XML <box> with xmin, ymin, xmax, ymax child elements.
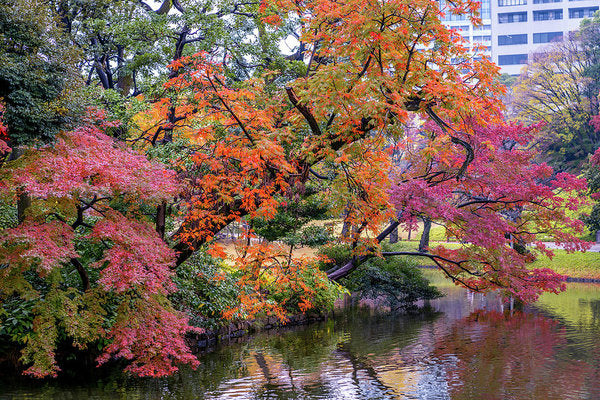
<box><xmin>435</xmin><ymin>310</ymin><xmax>593</xmax><ymax>400</ymax></box>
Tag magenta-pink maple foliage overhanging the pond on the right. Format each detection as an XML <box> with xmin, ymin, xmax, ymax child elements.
<box><xmin>391</xmin><ymin>125</ymin><xmax>588</xmax><ymax>301</ymax></box>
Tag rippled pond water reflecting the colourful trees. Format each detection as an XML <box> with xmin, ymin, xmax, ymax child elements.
<box><xmin>0</xmin><ymin>272</ymin><xmax>600</xmax><ymax>400</ymax></box>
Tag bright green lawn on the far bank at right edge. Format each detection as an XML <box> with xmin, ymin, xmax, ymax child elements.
<box><xmin>532</xmin><ymin>250</ymin><xmax>600</xmax><ymax>278</ymax></box>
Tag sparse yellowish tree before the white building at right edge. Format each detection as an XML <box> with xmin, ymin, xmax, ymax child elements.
<box><xmin>513</xmin><ymin>16</ymin><xmax>600</xmax><ymax>172</ymax></box>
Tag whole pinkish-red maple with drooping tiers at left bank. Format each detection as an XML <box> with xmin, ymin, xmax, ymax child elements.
<box><xmin>0</xmin><ymin>109</ymin><xmax>198</xmax><ymax>377</ymax></box>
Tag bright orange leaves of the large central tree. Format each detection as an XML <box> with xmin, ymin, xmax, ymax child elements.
<box><xmin>126</xmin><ymin>0</ymin><xmax>510</xmax><ymax>318</ymax></box>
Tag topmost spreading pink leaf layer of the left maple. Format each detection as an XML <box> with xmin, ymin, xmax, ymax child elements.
<box><xmin>5</xmin><ymin>110</ymin><xmax>178</xmax><ymax>201</ymax></box>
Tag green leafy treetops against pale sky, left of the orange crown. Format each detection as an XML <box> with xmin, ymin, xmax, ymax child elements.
<box><xmin>48</xmin><ymin>0</ymin><xmax>301</xmax><ymax>96</ymax></box>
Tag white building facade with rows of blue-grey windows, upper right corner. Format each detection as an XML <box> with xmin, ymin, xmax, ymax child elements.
<box><xmin>491</xmin><ymin>0</ymin><xmax>600</xmax><ymax>75</ymax></box>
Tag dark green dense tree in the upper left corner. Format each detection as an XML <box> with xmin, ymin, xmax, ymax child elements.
<box><xmin>0</xmin><ymin>0</ymin><xmax>83</xmax><ymax>147</ymax></box>
